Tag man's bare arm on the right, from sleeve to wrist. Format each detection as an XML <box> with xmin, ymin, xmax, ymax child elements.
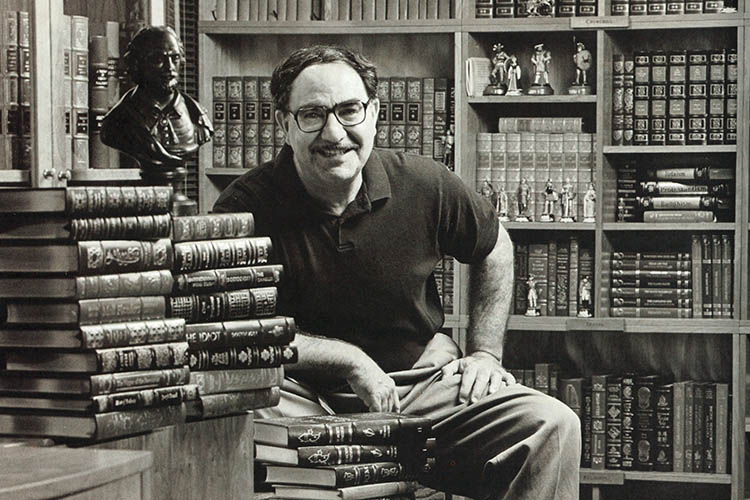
<box><xmin>466</xmin><ymin>226</ymin><xmax>513</xmax><ymax>360</ymax></box>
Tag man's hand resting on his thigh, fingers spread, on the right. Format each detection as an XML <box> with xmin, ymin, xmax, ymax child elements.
<box><xmin>443</xmin><ymin>351</ymin><xmax>516</xmax><ymax>404</ymax></box>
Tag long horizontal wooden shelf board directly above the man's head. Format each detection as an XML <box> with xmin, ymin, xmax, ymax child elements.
<box><xmin>198</xmin><ymin>19</ymin><xmax>461</xmax><ymax>35</ymax></box>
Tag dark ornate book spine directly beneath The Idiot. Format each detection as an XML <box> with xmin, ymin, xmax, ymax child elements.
<box><xmin>188</xmin><ymin>345</ymin><xmax>298</xmax><ymax>371</ymax></box>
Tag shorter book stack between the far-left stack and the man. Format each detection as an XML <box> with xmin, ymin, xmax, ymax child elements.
<box><xmin>168</xmin><ymin>212</ymin><xmax>297</xmax><ymax>419</ymax></box>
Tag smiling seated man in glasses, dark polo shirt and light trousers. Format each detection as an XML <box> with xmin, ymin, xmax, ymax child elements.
<box><xmin>214</xmin><ymin>46</ymin><xmax>580</xmax><ymax>500</ymax></box>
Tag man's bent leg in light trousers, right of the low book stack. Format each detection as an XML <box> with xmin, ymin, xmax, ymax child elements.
<box><xmin>402</xmin><ymin>375</ymin><xmax>581</xmax><ymax>500</ymax></box>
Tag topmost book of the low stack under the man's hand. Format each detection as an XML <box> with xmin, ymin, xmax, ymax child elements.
<box><xmin>255</xmin><ymin>412</ymin><xmax>432</xmax><ymax>448</ymax></box>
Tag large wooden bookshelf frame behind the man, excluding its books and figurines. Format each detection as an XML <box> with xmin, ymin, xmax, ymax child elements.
<box><xmin>199</xmin><ymin>0</ymin><xmax>750</xmax><ymax>499</ymax></box>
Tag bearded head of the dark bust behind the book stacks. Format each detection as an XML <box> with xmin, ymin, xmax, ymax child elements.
<box><xmin>140</xmin><ymin>33</ymin><xmax>182</xmax><ymax>96</ymax></box>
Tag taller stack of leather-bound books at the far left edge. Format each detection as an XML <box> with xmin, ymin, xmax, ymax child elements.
<box><xmin>0</xmin><ymin>187</ymin><xmax>197</xmax><ymax>440</ymax></box>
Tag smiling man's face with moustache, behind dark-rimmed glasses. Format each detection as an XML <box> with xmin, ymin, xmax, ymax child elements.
<box><xmin>276</xmin><ymin>62</ymin><xmax>380</xmax><ymax>191</ymax></box>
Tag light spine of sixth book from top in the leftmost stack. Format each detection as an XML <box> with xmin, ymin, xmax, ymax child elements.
<box><xmin>81</xmin><ymin>318</ymin><xmax>185</xmax><ymax>349</ymax></box>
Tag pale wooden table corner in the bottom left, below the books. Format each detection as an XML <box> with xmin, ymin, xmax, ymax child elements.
<box><xmin>0</xmin><ymin>446</ymin><xmax>152</xmax><ymax>500</ymax></box>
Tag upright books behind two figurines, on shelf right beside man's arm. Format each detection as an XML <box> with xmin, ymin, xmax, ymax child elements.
<box><xmin>511</xmin><ymin>235</ymin><xmax>594</xmax><ymax>317</ymax></box>
